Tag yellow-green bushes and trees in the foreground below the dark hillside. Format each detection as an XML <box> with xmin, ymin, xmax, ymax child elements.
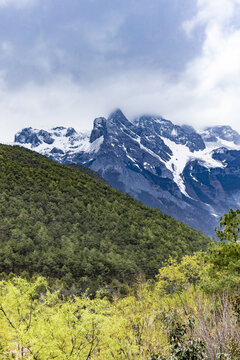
<box><xmin>0</xmin><ymin>210</ymin><xmax>240</xmax><ymax>360</ymax></box>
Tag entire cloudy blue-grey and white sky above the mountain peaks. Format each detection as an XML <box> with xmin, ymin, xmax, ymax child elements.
<box><xmin>0</xmin><ymin>0</ymin><xmax>240</xmax><ymax>142</ymax></box>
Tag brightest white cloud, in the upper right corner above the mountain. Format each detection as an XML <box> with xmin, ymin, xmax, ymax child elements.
<box><xmin>174</xmin><ymin>0</ymin><xmax>240</xmax><ymax>130</ymax></box>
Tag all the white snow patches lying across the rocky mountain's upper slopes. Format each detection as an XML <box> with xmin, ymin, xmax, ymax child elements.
<box><xmin>10</xmin><ymin>117</ymin><xmax>240</xmax><ymax>198</ymax></box>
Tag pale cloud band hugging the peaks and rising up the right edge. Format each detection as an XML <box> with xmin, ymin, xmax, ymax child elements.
<box><xmin>0</xmin><ymin>0</ymin><xmax>240</xmax><ymax>141</ymax></box>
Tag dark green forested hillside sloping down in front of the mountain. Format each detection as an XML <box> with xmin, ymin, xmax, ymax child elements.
<box><xmin>0</xmin><ymin>145</ymin><xmax>209</xmax><ymax>289</ymax></box>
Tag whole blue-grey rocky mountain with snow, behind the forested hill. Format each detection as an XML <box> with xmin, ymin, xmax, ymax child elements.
<box><xmin>15</xmin><ymin>110</ymin><xmax>240</xmax><ymax>234</ymax></box>
